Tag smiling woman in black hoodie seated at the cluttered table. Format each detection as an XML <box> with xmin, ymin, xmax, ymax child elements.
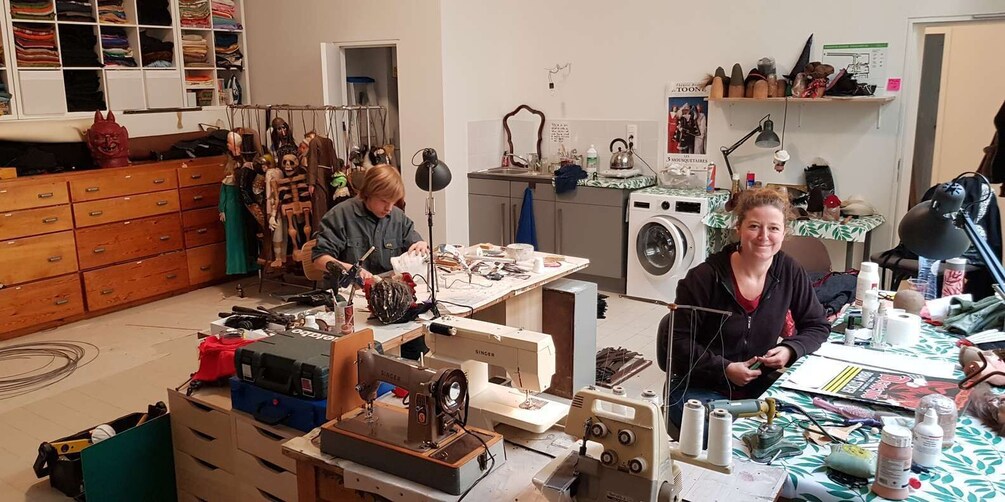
<box><xmin>656</xmin><ymin>189</ymin><xmax>830</xmax><ymax>428</ymax></box>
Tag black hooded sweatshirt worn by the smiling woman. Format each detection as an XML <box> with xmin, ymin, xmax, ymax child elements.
<box><xmin>656</xmin><ymin>241</ymin><xmax>830</xmax><ymax>399</ymax></box>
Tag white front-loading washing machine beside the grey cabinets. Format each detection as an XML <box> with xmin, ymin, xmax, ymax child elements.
<box><xmin>626</xmin><ymin>188</ymin><xmax>711</xmax><ymax>302</ymax></box>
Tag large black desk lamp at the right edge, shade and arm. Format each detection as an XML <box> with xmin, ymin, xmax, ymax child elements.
<box><xmin>897</xmin><ymin>173</ymin><xmax>1005</xmax><ymax>297</ymax></box>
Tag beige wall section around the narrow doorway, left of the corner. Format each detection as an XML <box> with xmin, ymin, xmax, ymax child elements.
<box><xmin>244</xmin><ymin>0</ymin><xmax>444</xmax><ymax>234</ymax></box>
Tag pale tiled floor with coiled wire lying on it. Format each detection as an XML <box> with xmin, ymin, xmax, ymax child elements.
<box><xmin>0</xmin><ymin>280</ymin><xmax>666</xmax><ymax>502</ymax></box>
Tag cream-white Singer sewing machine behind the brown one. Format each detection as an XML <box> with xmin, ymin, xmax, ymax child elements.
<box><xmin>426</xmin><ymin>316</ymin><xmax>569</xmax><ymax>433</ymax></box>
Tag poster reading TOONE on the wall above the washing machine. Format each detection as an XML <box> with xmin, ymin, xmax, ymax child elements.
<box><xmin>663</xmin><ymin>82</ymin><xmax>709</xmax><ymax>169</ymax></box>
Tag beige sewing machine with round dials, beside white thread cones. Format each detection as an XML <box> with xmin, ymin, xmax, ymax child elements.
<box><xmin>534</xmin><ymin>389</ymin><xmax>681</xmax><ymax>502</ymax></box>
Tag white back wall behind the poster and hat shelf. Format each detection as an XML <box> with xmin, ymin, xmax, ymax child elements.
<box><xmin>442</xmin><ymin>0</ymin><xmax>1005</xmax><ymax>266</ymax></box>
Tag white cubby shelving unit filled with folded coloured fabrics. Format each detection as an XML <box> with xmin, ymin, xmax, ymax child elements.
<box><xmin>0</xmin><ymin>0</ymin><xmax>249</xmax><ymax>120</ymax></box>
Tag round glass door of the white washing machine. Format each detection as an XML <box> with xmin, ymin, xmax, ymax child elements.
<box><xmin>635</xmin><ymin>217</ymin><xmax>692</xmax><ymax>277</ymax></box>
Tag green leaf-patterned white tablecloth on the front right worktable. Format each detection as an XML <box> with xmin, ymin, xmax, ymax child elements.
<box><xmin>734</xmin><ymin>325</ymin><xmax>1005</xmax><ymax>502</ymax></box>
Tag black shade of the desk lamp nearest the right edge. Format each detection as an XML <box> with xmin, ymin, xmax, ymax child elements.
<box><xmin>897</xmin><ymin>183</ymin><xmax>970</xmax><ymax>260</ymax></box>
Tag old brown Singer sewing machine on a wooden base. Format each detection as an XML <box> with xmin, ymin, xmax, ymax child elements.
<box><xmin>321</xmin><ymin>347</ymin><xmax>506</xmax><ymax>495</ymax></box>
